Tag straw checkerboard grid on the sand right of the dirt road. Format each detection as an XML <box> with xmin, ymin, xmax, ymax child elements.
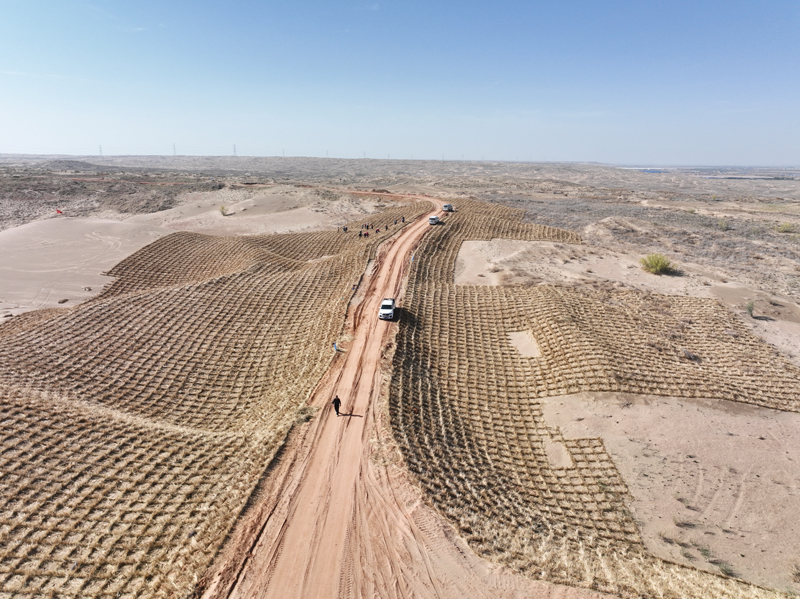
<box><xmin>390</xmin><ymin>199</ymin><xmax>800</xmax><ymax>599</ymax></box>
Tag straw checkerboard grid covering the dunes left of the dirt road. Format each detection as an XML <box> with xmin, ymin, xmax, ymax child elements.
<box><xmin>0</xmin><ymin>202</ymin><xmax>430</xmax><ymax>597</ymax></box>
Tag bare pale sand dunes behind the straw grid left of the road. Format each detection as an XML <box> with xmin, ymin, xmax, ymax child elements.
<box><xmin>0</xmin><ymin>186</ymin><xmax>396</xmax><ymax>315</ymax></box>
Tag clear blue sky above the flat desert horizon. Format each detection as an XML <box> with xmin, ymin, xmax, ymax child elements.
<box><xmin>0</xmin><ymin>0</ymin><xmax>800</xmax><ymax>166</ymax></box>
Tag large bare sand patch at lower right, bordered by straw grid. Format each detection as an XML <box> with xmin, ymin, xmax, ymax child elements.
<box><xmin>544</xmin><ymin>393</ymin><xmax>800</xmax><ymax>592</ymax></box>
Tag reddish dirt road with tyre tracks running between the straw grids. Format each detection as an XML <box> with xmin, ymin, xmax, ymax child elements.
<box><xmin>200</xmin><ymin>204</ymin><xmax>603</xmax><ymax>599</ymax></box>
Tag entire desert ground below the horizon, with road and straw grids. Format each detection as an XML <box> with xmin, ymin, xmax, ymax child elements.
<box><xmin>0</xmin><ymin>154</ymin><xmax>800</xmax><ymax>599</ymax></box>
